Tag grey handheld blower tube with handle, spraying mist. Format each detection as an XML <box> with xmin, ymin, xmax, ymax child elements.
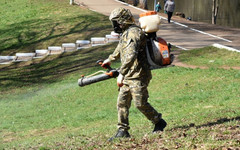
<box><xmin>78</xmin><ymin>60</ymin><xmax>119</xmax><ymax>87</ymax></box>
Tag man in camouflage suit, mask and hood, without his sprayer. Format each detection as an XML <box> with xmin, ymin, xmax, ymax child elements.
<box><xmin>102</xmin><ymin>8</ymin><xmax>166</xmax><ymax>141</ymax></box>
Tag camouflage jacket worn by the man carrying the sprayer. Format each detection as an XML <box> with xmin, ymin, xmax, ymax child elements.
<box><xmin>108</xmin><ymin>25</ymin><xmax>152</xmax><ymax>82</ymax></box>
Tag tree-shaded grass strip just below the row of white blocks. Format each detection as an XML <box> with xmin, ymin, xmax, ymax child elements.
<box><xmin>0</xmin><ymin>43</ymin><xmax>116</xmax><ymax>92</ymax></box>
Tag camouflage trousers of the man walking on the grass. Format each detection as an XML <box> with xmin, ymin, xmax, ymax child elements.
<box><xmin>117</xmin><ymin>80</ymin><xmax>161</xmax><ymax>130</ymax></box>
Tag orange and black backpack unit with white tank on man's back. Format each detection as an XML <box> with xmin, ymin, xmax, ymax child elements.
<box><xmin>139</xmin><ymin>11</ymin><xmax>174</xmax><ymax>67</ymax></box>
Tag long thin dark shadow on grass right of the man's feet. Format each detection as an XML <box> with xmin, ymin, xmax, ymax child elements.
<box><xmin>171</xmin><ymin>116</ymin><xmax>240</xmax><ymax>130</ymax></box>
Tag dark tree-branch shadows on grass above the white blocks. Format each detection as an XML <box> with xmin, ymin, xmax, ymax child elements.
<box><xmin>0</xmin><ymin>15</ymin><xmax>111</xmax><ymax>55</ymax></box>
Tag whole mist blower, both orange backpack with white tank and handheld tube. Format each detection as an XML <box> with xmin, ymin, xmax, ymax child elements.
<box><xmin>78</xmin><ymin>11</ymin><xmax>174</xmax><ymax>87</ymax></box>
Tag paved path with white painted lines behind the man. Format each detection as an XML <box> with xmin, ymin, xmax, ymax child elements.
<box><xmin>75</xmin><ymin>0</ymin><xmax>240</xmax><ymax>50</ymax></box>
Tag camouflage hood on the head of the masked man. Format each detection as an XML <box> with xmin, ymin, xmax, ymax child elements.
<box><xmin>109</xmin><ymin>7</ymin><xmax>135</xmax><ymax>24</ymax></box>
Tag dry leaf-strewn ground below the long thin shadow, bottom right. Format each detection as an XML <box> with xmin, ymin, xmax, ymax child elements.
<box><xmin>109</xmin><ymin>124</ymin><xmax>240</xmax><ymax>150</ymax></box>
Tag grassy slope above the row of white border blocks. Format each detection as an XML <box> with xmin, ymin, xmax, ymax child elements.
<box><xmin>0</xmin><ymin>0</ymin><xmax>111</xmax><ymax>55</ymax></box>
